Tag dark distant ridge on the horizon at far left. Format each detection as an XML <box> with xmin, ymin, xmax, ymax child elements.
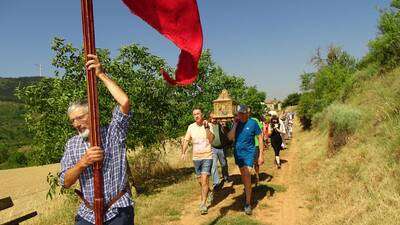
<box><xmin>0</xmin><ymin>77</ymin><xmax>43</xmax><ymax>102</ymax></box>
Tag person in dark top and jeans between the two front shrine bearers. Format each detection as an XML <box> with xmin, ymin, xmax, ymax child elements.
<box><xmin>210</xmin><ymin>113</ymin><xmax>229</xmax><ymax>191</ymax></box>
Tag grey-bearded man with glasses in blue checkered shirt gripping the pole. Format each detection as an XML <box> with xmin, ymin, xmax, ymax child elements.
<box><xmin>60</xmin><ymin>55</ymin><xmax>134</xmax><ymax>225</ymax></box>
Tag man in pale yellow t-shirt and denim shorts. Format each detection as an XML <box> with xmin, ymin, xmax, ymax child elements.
<box><xmin>181</xmin><ymin>108</ymin><xmax>214</xmax><ymax>215</ymax></box>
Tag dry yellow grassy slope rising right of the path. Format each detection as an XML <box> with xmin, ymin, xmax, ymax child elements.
<box><xmin>299</xmin><ymin>69</ymin><xmax>400</xmax><ymax>225</ymax></box>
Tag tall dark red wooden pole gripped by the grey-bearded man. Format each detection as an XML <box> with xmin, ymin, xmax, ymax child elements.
<box><xmin>81</xmin><ymin>0</ymin><xmax>104</xmax><ymax>225</ymax></box>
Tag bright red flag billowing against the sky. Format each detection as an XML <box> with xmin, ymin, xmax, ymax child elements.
<box><xmin>123</xmin><ymin>0</ymin><xmax>203</xmax><ymax>85</ymax></box>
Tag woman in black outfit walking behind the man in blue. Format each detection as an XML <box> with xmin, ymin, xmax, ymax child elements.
<box><xmin>268</xmin><ymin>111</ymin><xmax>285</xmax><ymax>169</ymax></box>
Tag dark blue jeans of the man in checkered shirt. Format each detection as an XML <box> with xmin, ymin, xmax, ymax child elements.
<box><xmin>75</xmin><ymin>206</ymin><xmax>135</xmax><ymax>225</ymax></box>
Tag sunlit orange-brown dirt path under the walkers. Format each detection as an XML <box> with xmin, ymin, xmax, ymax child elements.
<box><xmin>171</xmin><ymin>121</ymin><xmax>307</xmax><ymax>225</ymax></box>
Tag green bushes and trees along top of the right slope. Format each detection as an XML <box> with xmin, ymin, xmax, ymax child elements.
<box><xmin>298</xmin><ymin>0</ymin><xmax>400</xmax><ymax>128</ymax></box>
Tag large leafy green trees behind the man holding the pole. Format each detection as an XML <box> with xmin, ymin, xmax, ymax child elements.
<box><xmin>17</xmin><ymin>38</ymin><xmax>265</xmax><ymax>164</ymax></box>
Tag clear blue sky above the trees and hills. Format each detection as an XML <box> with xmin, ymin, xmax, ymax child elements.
<box><xmin>0</xmin><ymin>0</ymin><xmax>390</xmax><ymax>98</ymax></box>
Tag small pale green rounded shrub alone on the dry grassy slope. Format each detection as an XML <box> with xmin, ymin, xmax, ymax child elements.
<box><xmin>326</xmin><ymin>104</ymin><xmax>361</xmax><ymax>156</ymax></box>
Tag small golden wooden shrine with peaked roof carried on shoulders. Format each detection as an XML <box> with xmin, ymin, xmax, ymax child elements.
<box><xmin>213</xmin><ymin>89</ymin><xmax>236</xmax><ymax>119</ymax></box>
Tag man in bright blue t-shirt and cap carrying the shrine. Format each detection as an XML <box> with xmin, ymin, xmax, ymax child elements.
<box><xmin>228</xmin><ymin>105</ymin><xmax>264</xmax><ymax>215</ymax></box>
